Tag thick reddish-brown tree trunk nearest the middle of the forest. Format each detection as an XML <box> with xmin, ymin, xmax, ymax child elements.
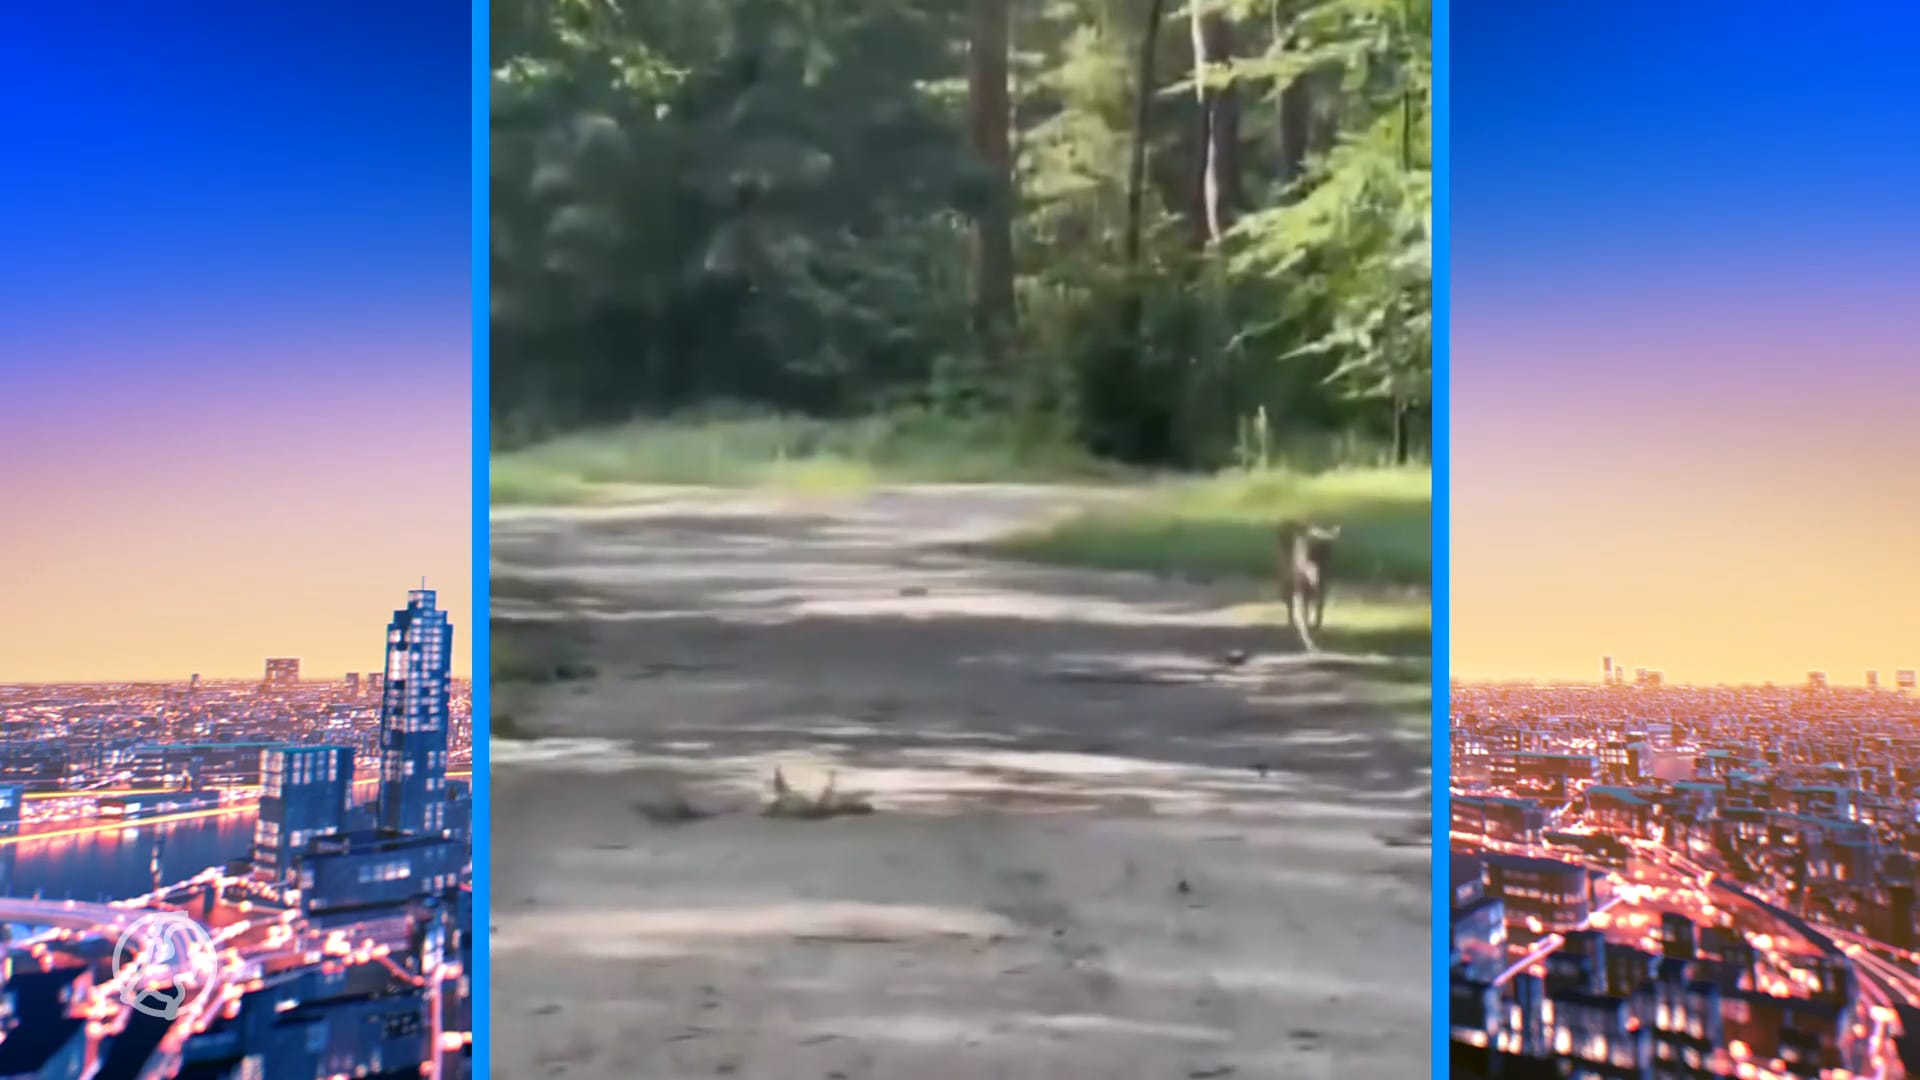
<box><xmin>968</xmin><ymin>0</ymin><xmax>1014</xmax><ymax>336</ymax></box>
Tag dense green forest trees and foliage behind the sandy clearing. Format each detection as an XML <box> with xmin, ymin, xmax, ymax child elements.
<box><xmin>492</xmin><ymin>0</ymin><xmax>1430</xmax><ymax>465</ymax></box>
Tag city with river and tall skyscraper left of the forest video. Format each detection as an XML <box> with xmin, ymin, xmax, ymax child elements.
<box><xmin>0</xmin><ymin>588</ymin><xmax>474</xmax><ymax>1080</ymax></box>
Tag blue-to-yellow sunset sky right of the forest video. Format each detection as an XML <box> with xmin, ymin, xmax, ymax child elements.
<box><xmin>1452</xmin><ymin>0</ymin><xmax>1920</xmax><ymax>684</ymax></box>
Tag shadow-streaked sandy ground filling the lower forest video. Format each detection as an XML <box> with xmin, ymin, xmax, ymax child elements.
<box><xmin>492</xmin><ymin>488</ymin><xmax>1430</xmax><ymax>1080</ymax></box>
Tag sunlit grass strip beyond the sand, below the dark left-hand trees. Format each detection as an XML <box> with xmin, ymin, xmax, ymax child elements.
<box><xmin>490</xmin><ymin>413</ymin><xmax>1112</xmax><ymax>505</ymax></box>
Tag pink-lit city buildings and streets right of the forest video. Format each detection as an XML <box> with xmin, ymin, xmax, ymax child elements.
<box><xmin>1448</xmin><ymin>673</ymin><xmax>1920</xmax><ymax>1076</ymax></box>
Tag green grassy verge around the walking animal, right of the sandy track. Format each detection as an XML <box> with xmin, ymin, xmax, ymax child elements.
<box><xmin>995</xmin><ymin>467</ymin><xmax>1432</xmax><ymax>657</ymax></box>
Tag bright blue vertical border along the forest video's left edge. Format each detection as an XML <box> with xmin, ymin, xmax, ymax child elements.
<box><xmin>468</xmin><ymin>0</ymin><xmax>493</xmax><ymax>1080</ymax></box>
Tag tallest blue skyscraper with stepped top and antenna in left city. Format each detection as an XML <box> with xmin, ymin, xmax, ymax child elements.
<box><xmin>380</xmin><ymin>588</ymin><xmax>453</xmax><ymax>834</ymax></box>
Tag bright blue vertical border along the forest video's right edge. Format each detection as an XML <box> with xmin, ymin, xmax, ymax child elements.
<box><xmin>1430</xmin><ymin>0</ymin><xmax>1453</xmax><ymax>1076</ymax></box>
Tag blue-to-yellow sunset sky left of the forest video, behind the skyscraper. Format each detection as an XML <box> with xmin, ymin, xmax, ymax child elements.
<box><xmin>0</xmin><ymin>2</ymin><xmax>472</xmax><ymax>680</ymax></box>
